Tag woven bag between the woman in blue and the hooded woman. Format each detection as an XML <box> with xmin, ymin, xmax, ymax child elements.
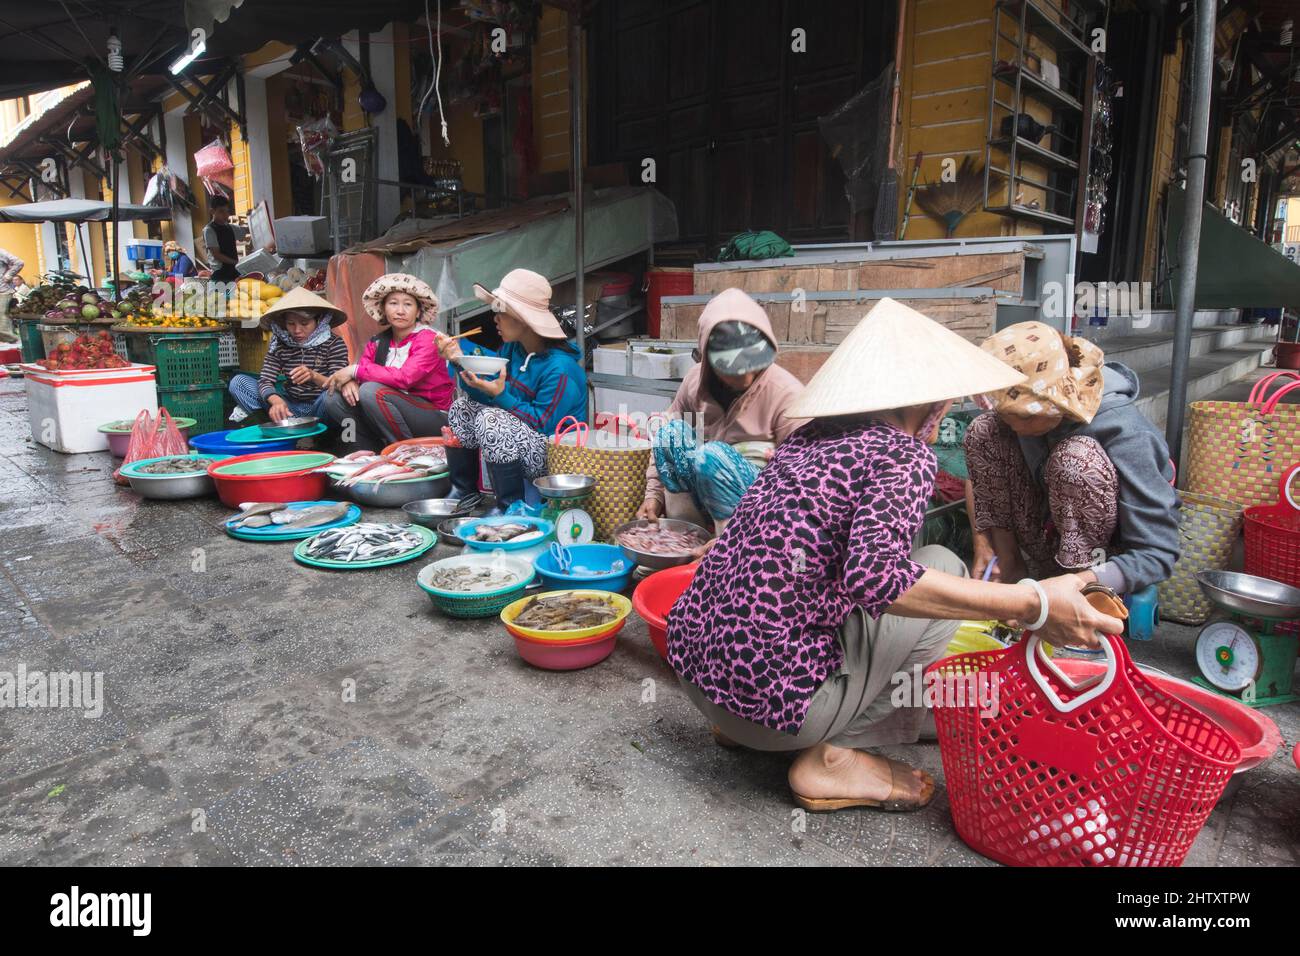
<box><xmin>546</xmin><ymin>418</ymin><xmax>650</xmax><ymax>541</ymax></box>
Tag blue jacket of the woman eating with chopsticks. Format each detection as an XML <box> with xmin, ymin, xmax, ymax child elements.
<box><xmin>460</xmin><ymin>341</ymin><xmax>586</xmax><ymax>436</ymax></box>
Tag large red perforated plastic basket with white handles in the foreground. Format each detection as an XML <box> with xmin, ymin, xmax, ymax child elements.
<box><xmin>927</xmin><ymin>635</ymin><xmax>1242</xmax><ymax>866</ymax></box>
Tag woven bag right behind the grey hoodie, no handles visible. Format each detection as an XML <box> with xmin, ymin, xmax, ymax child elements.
<box><xmin>1156</xmin><ymin>492</ymin><xmax>1242</xmax><ymax>624</ymax></box>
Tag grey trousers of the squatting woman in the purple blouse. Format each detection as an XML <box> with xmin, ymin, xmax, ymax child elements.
<box><xmin>681</xmin><ymin>545</ymin><xmax>967</xmax><ymax>750</ymax></box>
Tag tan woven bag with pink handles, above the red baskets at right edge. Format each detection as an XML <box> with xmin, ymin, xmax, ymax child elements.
<box><xmin>1186</xmin><ymin>372</ymin><xmax>1300</xmax><ymax>505</ymax></box>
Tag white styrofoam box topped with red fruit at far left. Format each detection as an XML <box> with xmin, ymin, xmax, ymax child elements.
<box><xmin>22</xmin><ymin>364</ymin><xmax>159</xmax><ymax>454</ymax></box>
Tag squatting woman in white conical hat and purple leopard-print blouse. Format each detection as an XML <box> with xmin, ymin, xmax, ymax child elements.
<box><xmin>668</xmin><ymin>299</ymin><xmax>1121</xmax><ymax>810</ymax></box>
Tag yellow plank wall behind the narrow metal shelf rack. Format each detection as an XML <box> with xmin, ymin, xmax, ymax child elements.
<box><xmin>894</xmin><ymin>0</ymin><xmax>1052</xmax><ymax>239</ymax></box>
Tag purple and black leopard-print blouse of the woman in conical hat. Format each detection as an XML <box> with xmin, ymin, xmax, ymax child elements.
<box><xmin>668</xmin><ymin>420</ymin><xmax>937</xmax><ymax>734</ymax></box>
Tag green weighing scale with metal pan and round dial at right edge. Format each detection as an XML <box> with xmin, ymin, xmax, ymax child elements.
<box><xmin>1193</xmin><ymin>571</ymin><xmax>1300</xmax><ymax>708</ymax></box>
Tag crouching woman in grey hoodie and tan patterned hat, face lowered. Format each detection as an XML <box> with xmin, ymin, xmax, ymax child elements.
<box><xmin>965</xmin><ymin>323</ymin><xmax>1182</xmax><ymax>594</ymax></box>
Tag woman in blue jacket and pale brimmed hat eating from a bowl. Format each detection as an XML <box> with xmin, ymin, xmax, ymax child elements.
<box><xmin>438</xmin><ymin>269</ymin><xmax>586</xmax><ymax>510</ymax></box>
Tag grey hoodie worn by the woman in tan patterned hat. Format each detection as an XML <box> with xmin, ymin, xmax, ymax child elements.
<box><xmin>1021</xmin><ymin>362</ymin><xmax>1182</xmax><ymax>593</ymax></box>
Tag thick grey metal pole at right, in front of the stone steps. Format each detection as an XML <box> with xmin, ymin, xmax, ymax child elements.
<box><xmin>1165</xmin><ymin>0</ymin><xmax>1218</xmax><ymax>462</ymax></box>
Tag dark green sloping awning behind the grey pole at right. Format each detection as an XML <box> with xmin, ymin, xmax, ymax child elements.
<box><xmin>1167</xmin><ymin>190</ymin><xmax>1300</xmax><ymax>308</ymax></box>
